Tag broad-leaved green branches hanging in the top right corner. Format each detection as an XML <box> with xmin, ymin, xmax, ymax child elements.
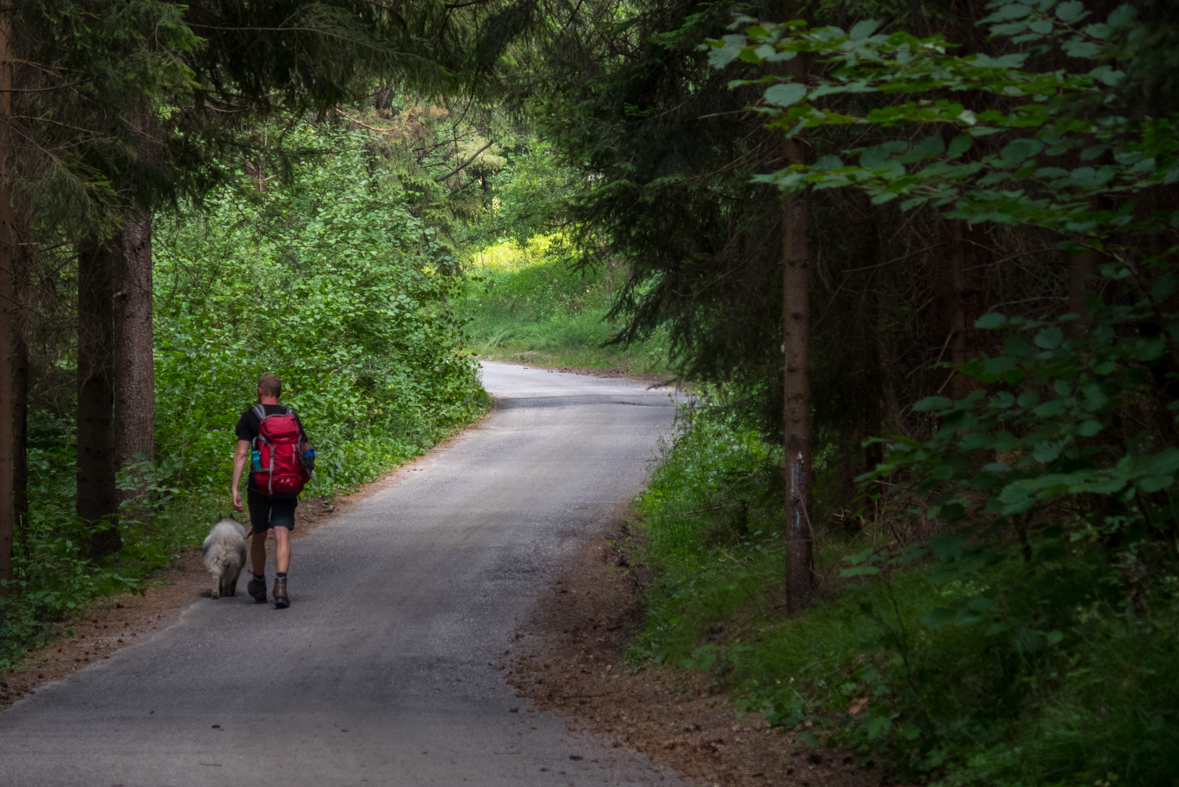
<box><xmin>709</xmin><ymin>0</ymin><xmax>1179</xmax><ymax>233</ymax></box>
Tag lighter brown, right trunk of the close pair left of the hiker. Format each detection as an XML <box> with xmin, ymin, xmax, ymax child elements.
<box><xmin>114</xmin><ymin>211</ymin><xmax>156</xmax><ymax>520</ymax></box>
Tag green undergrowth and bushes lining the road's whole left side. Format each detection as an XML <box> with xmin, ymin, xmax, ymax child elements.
<box><xmin>0</xmin><ymin>126</ymin><xmax>487</xmax><ymax>668</ymax></box>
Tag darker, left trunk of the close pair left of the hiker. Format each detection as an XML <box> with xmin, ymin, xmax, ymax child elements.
<box><xmin>77</xmin><ymin>233</ymin><xmax>123</xmax><ymax>557</ymax></box>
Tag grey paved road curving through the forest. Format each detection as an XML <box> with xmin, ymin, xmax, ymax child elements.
<box><xmin>0</xmin><ymin>364</ymin><xmax>679</xmax><ymax>787</ymax></box>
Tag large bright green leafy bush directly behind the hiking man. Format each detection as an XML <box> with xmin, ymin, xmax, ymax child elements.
<box><xmin>157</xmin><ymin>121</ymin><xmax>485</xmax><ymax>494</ymax></box>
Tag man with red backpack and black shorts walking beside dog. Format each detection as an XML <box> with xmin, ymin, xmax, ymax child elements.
<box><xmin>232</xmin><ymin>375</ymin><xmax>314</xmax><ymax>609</ymax></box>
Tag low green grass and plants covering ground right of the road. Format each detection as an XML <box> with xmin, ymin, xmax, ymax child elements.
<box><xmin>630</xmin><ymin>400</ymin><xmax>1179</xmax><ymax>786</ymax></box>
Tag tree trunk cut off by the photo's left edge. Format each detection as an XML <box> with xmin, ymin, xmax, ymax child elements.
<box><xmin>0</xmin><ymin>6</ymin><xmax>17</xmax><ymax>595</ymax></box>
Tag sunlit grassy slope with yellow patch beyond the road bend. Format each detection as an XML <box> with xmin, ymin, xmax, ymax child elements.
<box><xmin>467</xmin><ymin>233</ymin><xmax>666</xmax><ymax>373</ymax></box>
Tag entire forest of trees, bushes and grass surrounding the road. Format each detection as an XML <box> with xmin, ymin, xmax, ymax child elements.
<box><xmin>0</xmin><ymin>0</ymin><xmax>1179</xmax><ymax>787</ymax></box>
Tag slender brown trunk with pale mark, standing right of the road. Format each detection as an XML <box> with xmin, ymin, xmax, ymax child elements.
<box><xmin>782</xmin><ymin>0</ymin><xmax>815</xmax><ymax>613</ymax></box>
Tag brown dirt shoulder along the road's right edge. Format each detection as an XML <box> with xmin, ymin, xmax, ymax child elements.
<box><xmin>502</xmin><ymin>512</ymin><xmax>881</xmax><ymax>787</ymax></box>
